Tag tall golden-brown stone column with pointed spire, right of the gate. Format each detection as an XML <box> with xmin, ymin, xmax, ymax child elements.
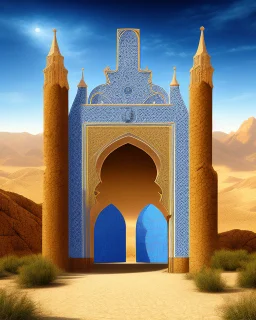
<box><xmin>189</xmin><ymin>27</ymin><xmax>218</xmax><ymax>272</ymax></box>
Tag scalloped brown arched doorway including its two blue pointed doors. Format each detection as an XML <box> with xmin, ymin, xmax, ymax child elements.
<box><xmin>90</xmin><ymin>137</ymin><xmax>171</xmax><ymax>263</ymax></box>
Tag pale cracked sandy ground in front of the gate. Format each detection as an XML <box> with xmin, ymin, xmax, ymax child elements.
<box><xmin>0</xmin><ymin>264</ymin><xmax>248</xmax><ymax>320</ymax></box>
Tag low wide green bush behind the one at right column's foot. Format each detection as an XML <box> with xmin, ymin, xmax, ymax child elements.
<box><xmin>211</xmin><ymin>250</ymin><xmax>250</xmax><ymax>271</ymax></box>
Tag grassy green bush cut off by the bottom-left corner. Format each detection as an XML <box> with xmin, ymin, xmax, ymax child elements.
<box><xmin>0</xmin><ymin>289</ymin><xmax>39</xmax><ymax>320</ymax></box>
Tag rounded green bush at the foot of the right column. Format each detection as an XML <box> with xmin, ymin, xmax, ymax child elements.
<box><xmin>194</xmin><ymin>268</ymin><xmax>226</xmax><ymax>292</ymax></box>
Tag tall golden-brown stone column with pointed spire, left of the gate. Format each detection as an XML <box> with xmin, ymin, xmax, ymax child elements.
<box><xmin>42</xmin><ymin>29</ymin><xmax>69</xmax><ymax>270</ymax></box>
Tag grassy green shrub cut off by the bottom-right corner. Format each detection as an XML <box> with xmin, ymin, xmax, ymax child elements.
<box><xmin>219</xmin><ymin>293</ymin><xmax>256</xmax><ymax>320</ymax></box>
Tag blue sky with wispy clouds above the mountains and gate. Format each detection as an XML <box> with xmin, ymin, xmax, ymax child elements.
<box><xmin>0</xmin><ymin>0</ymin><xmax>256</xmax><ymax>134</ymax></box>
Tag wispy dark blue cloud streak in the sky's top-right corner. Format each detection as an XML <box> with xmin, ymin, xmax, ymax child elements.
<box><xmin>210</xmin><ymin>0</ymin><xmax>256</xmax><ymax>27</ymax></box>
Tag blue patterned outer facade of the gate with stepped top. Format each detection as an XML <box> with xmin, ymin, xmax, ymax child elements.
<box><xmin>69</xmin><ymin>29</ymin><xmax>189</xmax><ymax>258</ymax></box>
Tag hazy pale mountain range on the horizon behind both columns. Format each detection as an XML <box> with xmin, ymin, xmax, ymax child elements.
<box><xmin>0</xmin><ymin>117</ymin><xmax>256</xmax><ymax>170</ymax></box>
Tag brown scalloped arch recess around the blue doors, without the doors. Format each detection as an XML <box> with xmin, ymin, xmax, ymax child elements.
<box><xmin>90</xmin><ymin>137</ymin><xmax>168</xmax><ymax>262</ymax></box>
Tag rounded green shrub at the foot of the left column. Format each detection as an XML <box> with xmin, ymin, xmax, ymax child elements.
<box><xmin>18</xmin><ymin>257</ymin><xmax>60</xmax><ymax>288</ymax></box>
